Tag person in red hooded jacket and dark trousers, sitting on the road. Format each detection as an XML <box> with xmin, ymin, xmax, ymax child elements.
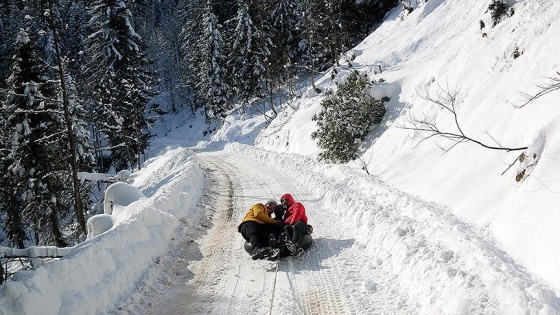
<box><xmin>280</xmin><ymin>194</ymin><xmax>308</xmax><ymax>256</ymax></box>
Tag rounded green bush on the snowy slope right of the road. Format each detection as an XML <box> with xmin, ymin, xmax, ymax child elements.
<box><xmin>311</xmin><ymin>71</ymin><xmax>387</xmax><ymax>163</ymax></box>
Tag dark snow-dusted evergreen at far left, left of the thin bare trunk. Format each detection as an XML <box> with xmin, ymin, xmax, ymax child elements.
<box><xmin>5</xmin><ymin>29</ymin><xmax>67</xmax><ymax>246</ymax></box>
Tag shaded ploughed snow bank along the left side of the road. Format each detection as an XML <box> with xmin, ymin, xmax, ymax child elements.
<box><xmin>0</xmin><ymin>149</ymin><xmax>203</xmax><ymax>315</ymax></box>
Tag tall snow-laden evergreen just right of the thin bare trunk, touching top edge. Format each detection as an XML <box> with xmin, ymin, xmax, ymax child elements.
<box><xmin>86</xmin><ymin>0</ymin><xmax>154</xmax><ymax>169</ymax></box>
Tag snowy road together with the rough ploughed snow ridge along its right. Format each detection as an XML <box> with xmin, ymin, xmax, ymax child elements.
<box><xmin>116</xmin><ymin>146</ymin><xmax>559</xmax><ymax>315</ymax></box>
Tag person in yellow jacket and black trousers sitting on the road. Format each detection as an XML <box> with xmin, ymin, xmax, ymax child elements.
<box><xmin>237</xmin><ymin>200</ymin><xmax>281</xmax><ymax>260</ymax></box>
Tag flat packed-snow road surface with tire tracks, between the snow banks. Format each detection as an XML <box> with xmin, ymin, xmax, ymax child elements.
<box><xmin>114</xmin><ymin>152</ymin><xmax>412</xmax><ymax>315</ymax></box>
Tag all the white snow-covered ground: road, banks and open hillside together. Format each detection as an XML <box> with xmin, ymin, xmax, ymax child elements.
<box><xmin>0</xmin><ymin>0</ymin><xmax>560</xmax><ymax>314</ymax></box>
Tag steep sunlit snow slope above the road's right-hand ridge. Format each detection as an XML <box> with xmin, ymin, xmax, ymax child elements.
<box><xmin>256</xmin><ymin>0</ymin><xmax>560</xmax><ymax>288</ymax></box>
